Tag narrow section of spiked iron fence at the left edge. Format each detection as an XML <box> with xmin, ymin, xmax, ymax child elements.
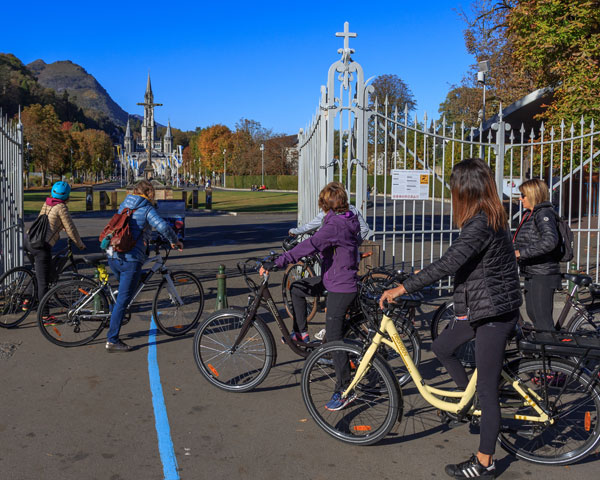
<box><xmin>0</xmin><ymin>111</ymin><xmax>23</xmax><ymax>274</ymax></box>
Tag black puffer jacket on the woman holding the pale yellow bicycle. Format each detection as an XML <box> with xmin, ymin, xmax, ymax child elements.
<box><xmin>403</xmin><ymin>212</ymin><xmax>522</xmax><ymax>322</ymax></box>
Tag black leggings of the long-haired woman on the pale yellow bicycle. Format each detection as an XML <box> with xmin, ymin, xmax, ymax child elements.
<box><xmin>431</xmin><ymin>310</ymin><xmax>519</xmax><ymax>455</ymax></box>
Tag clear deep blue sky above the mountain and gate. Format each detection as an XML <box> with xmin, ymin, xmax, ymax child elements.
<box><xmin>0</xmin><ymin>0</ymin><xmax>473</xmax><ymax>134</ymax></box>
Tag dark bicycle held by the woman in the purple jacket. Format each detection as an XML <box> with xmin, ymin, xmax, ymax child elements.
<box><xmin>194</xmin><ymin>255</ymin><xmax>421</xmax><ymax>392</ymax></box>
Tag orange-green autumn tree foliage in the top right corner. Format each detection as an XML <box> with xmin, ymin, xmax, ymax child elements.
<box><xmin>507</xmin><ymin>0</ymin><xmax>600</xmax><ymax>125</ymax></box>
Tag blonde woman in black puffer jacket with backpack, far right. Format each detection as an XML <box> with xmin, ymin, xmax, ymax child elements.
<box><xmin>513</xmin><ymin>178</ymin><xmax>561</xmax><ymax>330</ymax></box>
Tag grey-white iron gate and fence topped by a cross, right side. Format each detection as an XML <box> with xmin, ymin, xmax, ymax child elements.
<box><xmin>298</xmin><ymin>23</ymin><xmax>600</xmax><ymax>288</ymax></box>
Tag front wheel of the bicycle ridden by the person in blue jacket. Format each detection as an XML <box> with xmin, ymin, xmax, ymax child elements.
<box><xmin>152</xmin><ymin>272</ymin><xmax>204</xmax><ymax>337</ymax></box>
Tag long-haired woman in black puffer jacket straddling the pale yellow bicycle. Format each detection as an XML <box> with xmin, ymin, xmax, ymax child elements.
<box><xmin>381</xmin><ymin>158</ymin><xmax>522</xmax><ymax>479</ymax></box>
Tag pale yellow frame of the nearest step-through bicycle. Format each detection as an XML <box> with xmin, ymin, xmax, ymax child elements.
<box><xmin>342</xmin><ymin>315</ymin><xmax>553</xmax><ymax>423</ymax></box>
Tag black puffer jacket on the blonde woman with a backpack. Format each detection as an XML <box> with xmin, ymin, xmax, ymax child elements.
<box><xmin>514</xmin><ymin>202</ymin><xmax>560</xmax><ymax>276</ymax></box>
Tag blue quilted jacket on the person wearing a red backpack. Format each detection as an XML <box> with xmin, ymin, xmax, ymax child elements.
<box><xmin>112</xmin><ymin>195</ymin><xmax>178</xmax><ymax>263</ymax></box>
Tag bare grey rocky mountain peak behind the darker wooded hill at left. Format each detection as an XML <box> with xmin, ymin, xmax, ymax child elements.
<box><xmin>27</xmin><ymin>60</ymin><xmax>127</xmax><ymax>126</ymax></box>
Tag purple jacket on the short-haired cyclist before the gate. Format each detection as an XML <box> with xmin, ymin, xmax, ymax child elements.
<box><xmin>275</xmin><ymin>211</ymin><xmax>361</xmax><ymax>293</ymax></box>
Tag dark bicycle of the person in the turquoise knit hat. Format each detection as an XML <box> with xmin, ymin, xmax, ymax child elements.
<box><xmin>0</xmin><ymin>240</ymin><xmax>86</xmax><ymax>328</ymax></box>
